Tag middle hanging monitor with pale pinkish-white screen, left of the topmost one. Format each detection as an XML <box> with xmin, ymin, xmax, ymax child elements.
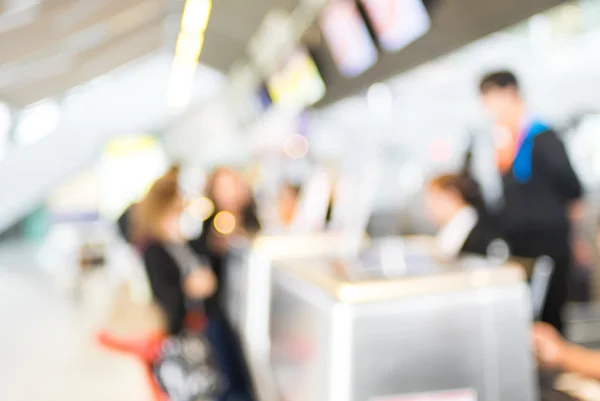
<box><xmin>320</xmin><ymin>0</ymin><xmax>377</xmax><ymax>78</ymax></box>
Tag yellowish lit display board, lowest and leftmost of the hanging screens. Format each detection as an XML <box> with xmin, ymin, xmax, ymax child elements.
<box><xmin>266</xmin><ymin>48</ymin><xmax>326</xmax><ymax>109</ymax></box>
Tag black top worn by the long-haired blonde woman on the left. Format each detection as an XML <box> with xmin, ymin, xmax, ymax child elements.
<box><xmin>144</xmin><ymin>242</ymin><xmax>187</xmax><ymax>334</ymax></box>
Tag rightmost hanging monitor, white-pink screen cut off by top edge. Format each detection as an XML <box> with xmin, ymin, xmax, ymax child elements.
<box><xmin>360</xmin><ymin>0</ymin><xmax>431</xmax><ymax>52</ymax></box>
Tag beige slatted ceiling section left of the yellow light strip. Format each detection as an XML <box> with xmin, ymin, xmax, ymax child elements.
<box><xmin>0</xmin><ymin>0</ymin><xmax>176</xmax><ymax>108</ymax></box>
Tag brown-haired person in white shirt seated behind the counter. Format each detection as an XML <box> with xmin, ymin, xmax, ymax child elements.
<box><xmin>425</xmin><ymin>174</ymin><xmax>498</xmax><ymax>259</ymax></box>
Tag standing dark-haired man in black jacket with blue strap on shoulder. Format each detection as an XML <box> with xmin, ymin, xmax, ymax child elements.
<box><xmin>479</xmin><ymin>71</ymin><xmax>582</xmax><ymax>331</ymax></box>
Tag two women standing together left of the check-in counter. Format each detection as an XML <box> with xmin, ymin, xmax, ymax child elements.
<box><xmin>118</xmin><ymin>166</ymin><xmax>260</xmax><ymax>401</ymax></box>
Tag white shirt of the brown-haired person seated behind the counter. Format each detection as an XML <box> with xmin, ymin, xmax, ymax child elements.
<box><xmin>436</xmin><ymin>206</ymin><xmax>479</xmax><ymax>259</ymax></box>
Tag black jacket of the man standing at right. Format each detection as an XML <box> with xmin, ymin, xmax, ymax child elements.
<box><xmin>500</xmin><ymin>130</ymin><xmax>582</xmax><ymax>236</ymax></box>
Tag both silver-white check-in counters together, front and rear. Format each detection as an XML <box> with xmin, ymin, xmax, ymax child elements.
<box><xmin>224</xmin><ymin>236</ymin><xmax>570</xmax><ymax>401</ymax></box>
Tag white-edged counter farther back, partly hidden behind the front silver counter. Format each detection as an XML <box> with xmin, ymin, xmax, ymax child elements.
<box><xmin>223</xmin><ymin>234</ymin><xmax>360</xmax><ymax>401</ymax></box>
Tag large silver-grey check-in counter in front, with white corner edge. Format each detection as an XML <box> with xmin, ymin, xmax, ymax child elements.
<box><xmin>269</xmin><ymin>258</ymin><xmax>538</xmax><ymax>401</ymax></box>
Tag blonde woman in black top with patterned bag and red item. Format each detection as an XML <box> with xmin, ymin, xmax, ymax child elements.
<box><xmin>100</xmin><ymin>169</ymin><xmax>227</xmax><ymax>399</ymax></box>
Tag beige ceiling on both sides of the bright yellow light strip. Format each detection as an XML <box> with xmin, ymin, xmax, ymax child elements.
<box><xmin>0</xmin><ymin>0</ymin><xmax>290</xmax><ymax>108</ymax></box>
